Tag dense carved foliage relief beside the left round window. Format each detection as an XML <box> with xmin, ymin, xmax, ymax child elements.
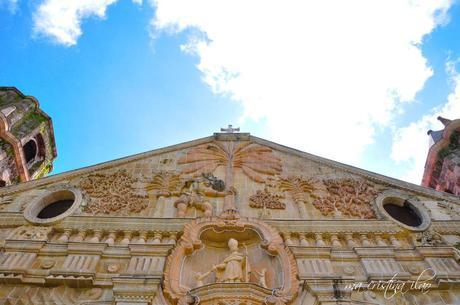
<box><xmin>80</xmin><ymin>170</ymin><xmax>147</xmax><ymax>215</ymax></box>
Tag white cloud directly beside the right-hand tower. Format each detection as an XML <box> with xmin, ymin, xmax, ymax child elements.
<box><xmin>391</xmin><ymin>61</ymin><xmax>460</xmax><ymax>184</ymax></box>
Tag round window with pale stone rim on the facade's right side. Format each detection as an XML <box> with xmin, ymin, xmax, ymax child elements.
<box><xmin>376</xmin><ymin>192</ymin><xmax>430</xmax><ymax>231</ymax></box>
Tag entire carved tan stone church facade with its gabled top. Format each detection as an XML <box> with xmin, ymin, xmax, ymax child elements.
<box><xmin>0</xmin><ymin>89</ymin><xmax>460</xmax><ymax>305</ymax></box>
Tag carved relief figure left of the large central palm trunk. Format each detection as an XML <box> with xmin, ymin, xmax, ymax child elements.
<box><xmin>174</xmin><ymin>174</ymin><xmax>225</xmax><ymax>217</ymax></box>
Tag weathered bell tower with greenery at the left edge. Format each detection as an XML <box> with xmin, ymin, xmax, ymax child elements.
<box><xmin>0</xmin><ymin>87</ymin><xmax>57</xmax><ymax>187</ymax></box>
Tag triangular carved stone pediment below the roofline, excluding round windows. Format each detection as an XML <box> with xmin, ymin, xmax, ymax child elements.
<box><xmin>0</xmin><ymin>133</ymin><xmax>459</xmax><ymax>221</ymax></box>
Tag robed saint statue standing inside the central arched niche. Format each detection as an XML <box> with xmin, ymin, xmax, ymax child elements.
<box><xmin>196</xmin><ymin>238</ymin><xmax>251</xmax><ymax>286</ymax></box>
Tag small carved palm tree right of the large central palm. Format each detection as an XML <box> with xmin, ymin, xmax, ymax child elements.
<box><xmin>279</xmin><ymin>176</ymin><xmax>317</xmax><ymax>218</ymax></box>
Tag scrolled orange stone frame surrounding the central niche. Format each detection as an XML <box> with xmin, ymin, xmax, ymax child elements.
<box><xmin>163</xmin><ymin>218</ymin><xmax>299</xmax><ymax>305</ymax></box>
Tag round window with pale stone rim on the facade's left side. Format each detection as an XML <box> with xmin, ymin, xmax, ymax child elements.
<box><xmin>24</xmin><ymin>188</ymin><xmax>82</xmax><ymax>224</ymax></box>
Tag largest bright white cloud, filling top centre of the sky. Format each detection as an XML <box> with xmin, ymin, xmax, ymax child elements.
<box><xmin>151</xmin><ymin>0</ymin><xmax>451</xmax><ymax>164</ymax></box>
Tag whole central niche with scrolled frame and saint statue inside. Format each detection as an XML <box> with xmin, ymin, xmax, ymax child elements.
<box><xmin>164</xmin><ymin>216</ymin><xmax>298</xmax><ymax>305</ymax></box>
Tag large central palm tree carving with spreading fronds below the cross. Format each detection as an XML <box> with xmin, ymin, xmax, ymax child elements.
<box><xmin>178</xmin><ymin>141</ymin><xmax>281</xmax><ymax>211</ymax></box>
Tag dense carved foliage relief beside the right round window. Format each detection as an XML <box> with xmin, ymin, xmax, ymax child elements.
<box><xmin>313</xmin><ymin>178</ymin><xmax>377</xmax><ymax>219</ymax></box>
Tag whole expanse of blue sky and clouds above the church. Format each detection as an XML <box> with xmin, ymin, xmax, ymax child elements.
<box><xmin>0</xmin><ymin>0</ymin><xmax>460</xmax><ymax>183</ymax></box>
